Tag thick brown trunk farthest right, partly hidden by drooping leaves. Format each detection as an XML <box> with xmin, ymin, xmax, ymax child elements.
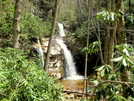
<box><xmin>115</xmin><ymin>0</ymin><xmax>129</xmax><ymax>99</ymax></box>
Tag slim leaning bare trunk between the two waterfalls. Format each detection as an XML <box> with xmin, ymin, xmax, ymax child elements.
<box><xmin>44</xmin><ymin>0</ymin><xmax>59</xmax><ymax>71</ymax></box>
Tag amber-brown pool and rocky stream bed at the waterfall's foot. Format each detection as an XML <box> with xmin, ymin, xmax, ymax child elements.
<box><xmin>60</xmin><ymin>79</ymin><xmax>93</xmax><ymax>101</ymax></box>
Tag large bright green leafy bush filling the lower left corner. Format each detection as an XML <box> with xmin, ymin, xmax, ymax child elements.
<box><xmin>0</xmin><ymin>48</ymin><xmax>62</xmax><ymax>101</ymax></box>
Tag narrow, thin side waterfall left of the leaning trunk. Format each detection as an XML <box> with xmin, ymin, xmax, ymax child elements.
<box><xmin>37</xmin><ymin>38</ymin><xmax>44</xmax><ymax>67</ymax></box>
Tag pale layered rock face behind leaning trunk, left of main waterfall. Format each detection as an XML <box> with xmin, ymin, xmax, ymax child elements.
<box><xmin>41</xmin><ymin>38</ymin><xmax>64</xmax><ymax>79</ymax></box>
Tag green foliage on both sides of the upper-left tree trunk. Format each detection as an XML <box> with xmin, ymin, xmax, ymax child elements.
<box><xmin>0</xmin><ymin>0</ymin><xmax>51</xmax><ymax>47</ymax></box>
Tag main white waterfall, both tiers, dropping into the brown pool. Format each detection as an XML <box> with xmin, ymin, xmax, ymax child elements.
<box><xmin>56</xmin><ymin>23</ymin><xmax>83</xmax><ymax>80</ymax></box>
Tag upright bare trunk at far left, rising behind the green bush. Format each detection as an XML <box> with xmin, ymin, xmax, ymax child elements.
<box><xmin>13</xmin><ymin>0</ymin><xmax>22</xmax><ymax>48</ymax></box>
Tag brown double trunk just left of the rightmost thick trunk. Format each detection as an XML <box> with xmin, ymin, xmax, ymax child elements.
<box><xmin>104</xmin><ymin>0</ymin><xmax>117</xmax><ymax>66</ymax></box>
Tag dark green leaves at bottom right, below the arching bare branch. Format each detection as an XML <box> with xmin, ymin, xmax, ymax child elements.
<box><xmin>90</xmin><ymin>80</ymin><xmax>127</xmax><ymax>101</ymax></box>
